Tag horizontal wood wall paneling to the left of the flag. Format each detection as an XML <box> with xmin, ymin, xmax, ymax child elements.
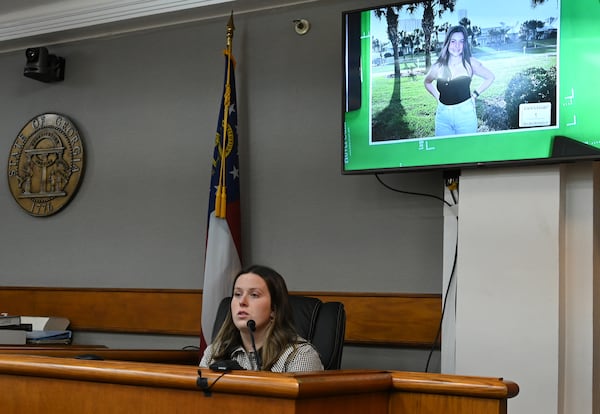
<box><xmin>0</xmin><ymin>287</ymin><xmax>202</xmax><ymax>335</ymax></box>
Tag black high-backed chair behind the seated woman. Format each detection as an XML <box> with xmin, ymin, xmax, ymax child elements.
<box><xmin>212</xmin><ymin>296</ymin><xmax>346</xmax><ymax>369</ymax></box>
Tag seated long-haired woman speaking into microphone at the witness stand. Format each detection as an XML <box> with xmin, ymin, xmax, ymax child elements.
<box><xmin>200</xmin><ymin>265</ymin><xmax>323</xmax><ymax>372</ymax></box>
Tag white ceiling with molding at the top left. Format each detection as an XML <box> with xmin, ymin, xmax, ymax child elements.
<box><xmin>0</xmin><ymin>0</ymin><xmax>324</xmax><ymax>53</ymax></box>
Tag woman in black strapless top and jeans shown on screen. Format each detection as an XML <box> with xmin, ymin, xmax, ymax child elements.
<box><xmin>425</xmin><ymin>26</ymin><xmax>494</xmax><ymax>136</ymax></box>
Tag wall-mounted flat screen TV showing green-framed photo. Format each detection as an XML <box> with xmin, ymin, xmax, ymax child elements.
<box><xmin>342</xmin><ymin>0</ymin><xmax>600</xmax><ymax>174</ymax></box>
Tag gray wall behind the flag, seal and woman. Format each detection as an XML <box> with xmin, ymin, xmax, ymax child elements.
<box><xmin>0</xmin><ymin>1</ymin><xmax>443</xmax><ymax>370</ymax></box>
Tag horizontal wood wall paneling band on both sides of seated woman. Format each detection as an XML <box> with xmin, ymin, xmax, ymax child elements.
<box><xmin>0</xmin><ymin>287</ymin><xmax>441</xmax><ymax>346</ymax></box>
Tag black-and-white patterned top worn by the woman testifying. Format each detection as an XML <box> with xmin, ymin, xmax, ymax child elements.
<box><xmin>200</xmin><ymin>340</ymin><xmax>323</xmax><ymax>372</ymax></box>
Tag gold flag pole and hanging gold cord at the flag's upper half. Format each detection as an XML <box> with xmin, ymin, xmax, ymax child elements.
<box><xmin>215</xmin><ymin>11</ymin><xmax>235</xmax><ymax>218</ymax></box>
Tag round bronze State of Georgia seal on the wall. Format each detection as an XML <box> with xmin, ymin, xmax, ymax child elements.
<box><xmin>8</xmin><ymin>114</ymin><xmax>84</xmax><ymax>217</ymax></box>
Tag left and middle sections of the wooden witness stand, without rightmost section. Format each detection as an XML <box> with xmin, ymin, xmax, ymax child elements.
<box><xmin>0</xmin><ymin>355</ymin><xmax>391</xmax><ymax>414</ymax></box>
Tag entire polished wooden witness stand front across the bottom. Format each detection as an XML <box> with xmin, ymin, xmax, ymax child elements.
<box><xmin>0</xmin><ymin>354</ymin><xmax>518</xmax><ymax>414</ymax></box>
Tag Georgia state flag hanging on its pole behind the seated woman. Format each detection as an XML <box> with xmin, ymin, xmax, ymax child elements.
<box><xmin>200</xmin><ymin>13</ymin><xmax>241</xmax><ymax>352</ymax></box>
